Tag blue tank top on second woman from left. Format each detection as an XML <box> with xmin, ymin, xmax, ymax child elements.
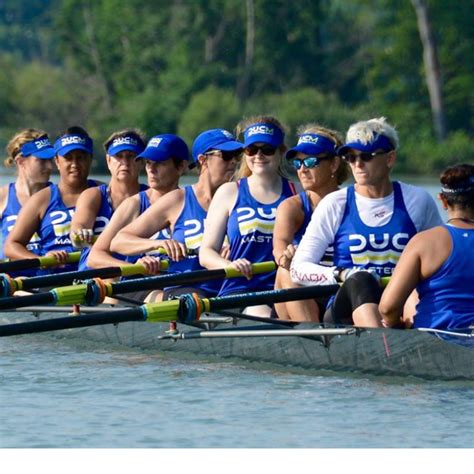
<box><xmin>38</xmin><ymin>179</ymin><xmax>97</xmax><ymax>273</ymax></box>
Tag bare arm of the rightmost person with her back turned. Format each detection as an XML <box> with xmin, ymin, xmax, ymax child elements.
<box><xmin>379</xmin><ymin>234</ymin><xmax>425</xmax><ymax>327</ymax></box>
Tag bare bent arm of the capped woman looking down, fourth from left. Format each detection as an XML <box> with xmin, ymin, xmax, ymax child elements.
<box><xmin>87</xmin><ymin>195</ymin><xmax>140</xmax><ymax>268</ymax></box>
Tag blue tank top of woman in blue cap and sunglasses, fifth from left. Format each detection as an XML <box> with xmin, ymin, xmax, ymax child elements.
<box><xmin>169</xmin><ymin>186</ymin><xmax>222</xmax><ymax>296</ymax></box>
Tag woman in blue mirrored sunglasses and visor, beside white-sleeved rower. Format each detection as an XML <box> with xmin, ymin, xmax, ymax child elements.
<box><xmin>273</xmin><ymin>124</ymin><xmax>349</xmax><ymax>321</ymax></box>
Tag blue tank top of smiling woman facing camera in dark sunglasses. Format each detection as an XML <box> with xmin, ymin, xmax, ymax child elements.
<box><xmin>219</xmin><ymin>178</ymin><xmax>295</xmax><ymax>295</ymax></box>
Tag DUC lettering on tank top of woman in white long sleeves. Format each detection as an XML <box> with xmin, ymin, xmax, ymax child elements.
<box><xmin>349</xmin><ymin>232</ymin><xmax>410</xmax><ymax>267</ymax></box>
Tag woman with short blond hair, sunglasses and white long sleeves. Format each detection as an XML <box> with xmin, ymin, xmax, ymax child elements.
<box><xmin>291</xmin><ymin>118</ymin><xmax>442</xmax><ymax>327</ymax></box>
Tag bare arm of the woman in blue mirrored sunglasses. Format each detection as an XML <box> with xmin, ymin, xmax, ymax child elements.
<box><xmin>273</xmin><ymin>196</ymin><xmax>304</xmax><ymax>270</ymax></box>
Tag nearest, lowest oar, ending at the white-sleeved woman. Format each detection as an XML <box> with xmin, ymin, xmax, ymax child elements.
<box><xmin>0</xmin><ymin>285</ymin><xmax>339</xmax><ymax>337</ymax></box>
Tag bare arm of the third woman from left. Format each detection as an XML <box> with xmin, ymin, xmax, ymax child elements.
<box><xmin>69</xmin><ymin>187</ymin><xmax>101</xmax><ymax>248</ymax></box>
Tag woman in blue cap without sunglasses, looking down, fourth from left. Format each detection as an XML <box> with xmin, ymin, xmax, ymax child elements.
<box><xmin>87</xmin><ymin>134</ymin><xmax>189</xmax><ymax>268</ymax></box>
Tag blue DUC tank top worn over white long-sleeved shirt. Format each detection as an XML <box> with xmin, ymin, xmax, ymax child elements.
<box><xmin>334</xmin><ymin>181</ymin><xmax>416</xmax><ymax>276</ymax></box>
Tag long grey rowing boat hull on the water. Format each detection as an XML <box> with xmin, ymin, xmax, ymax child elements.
<box><xmin>4</xmin><ymin>308</ymin><xmax>474</xmax><ymax>381</ymax></box>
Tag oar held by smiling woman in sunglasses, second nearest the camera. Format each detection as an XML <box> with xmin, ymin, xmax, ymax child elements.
<box><xmin>0</xmin><ymin>262</ymin><xmax>276</xmax><ymax>310</ymax></box>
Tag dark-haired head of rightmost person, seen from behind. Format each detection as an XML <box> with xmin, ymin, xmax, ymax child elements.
<box><xmin>439</xmin><ymin>164</ymin><xmax>474</xmax><ymax>209</ymax></box>
